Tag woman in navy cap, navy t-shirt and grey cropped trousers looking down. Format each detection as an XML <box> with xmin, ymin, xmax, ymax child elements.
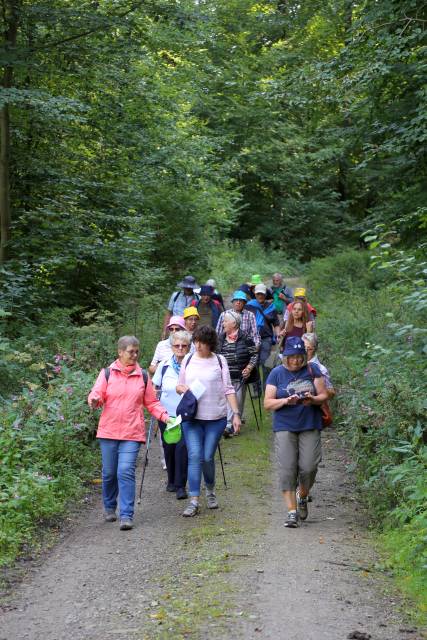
<box><xmin>264</xmin><ymin>337</ymin><xmax>328</xmax><ymax>528</ymax></box>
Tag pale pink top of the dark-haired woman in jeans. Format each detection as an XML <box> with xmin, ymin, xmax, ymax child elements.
<box><xmin>178</xmin><ymin>353</ymin><xmax>236</xmax><ymax>420</ymax></box>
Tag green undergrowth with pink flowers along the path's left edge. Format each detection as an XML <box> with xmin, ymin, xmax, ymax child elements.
<box><xmin>0</xmin><ymin>310</ymin><xmax>121</xmax><ymax>564</ymax></box>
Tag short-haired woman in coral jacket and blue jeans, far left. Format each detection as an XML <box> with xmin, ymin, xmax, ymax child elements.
<box><xmin>88</xmin><ymin>336</ymin><xmax>169</xmax><ymax>531</ymax></box>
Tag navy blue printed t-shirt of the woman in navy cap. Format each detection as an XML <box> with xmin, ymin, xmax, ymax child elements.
<box><xmin>267</xmin><ymin>363</ymin><xmax>322</xmax><ymax>431</ymax></box>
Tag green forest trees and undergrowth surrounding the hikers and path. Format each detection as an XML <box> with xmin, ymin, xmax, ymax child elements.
<box><xmin>0</xmin><ymin>0</ymin><xmax>427</xmax><ymax>613</ymax></box>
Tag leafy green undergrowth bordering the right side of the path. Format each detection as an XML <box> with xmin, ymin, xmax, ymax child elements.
<box><xmin>307</xmin><ymin>246</ymin><xmax>427</xmax><ymax>616</ymax></box>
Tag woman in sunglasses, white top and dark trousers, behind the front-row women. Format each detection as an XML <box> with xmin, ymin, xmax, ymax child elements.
<box><xmin>153</xmin><ymin>331</ymin><xmax>191</xmax><ymax>500</ymax></box>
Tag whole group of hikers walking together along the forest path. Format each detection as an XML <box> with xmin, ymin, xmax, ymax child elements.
<box><xmin>88</xmin><ymin>273</ymin><xmax>335</xmax><ymax>530</ymax></box>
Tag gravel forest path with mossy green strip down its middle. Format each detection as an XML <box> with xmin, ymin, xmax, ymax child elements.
<box><xmin>0</xmin><ymin>418</ymin><xmax>422</xmax><ymax>640</ymax></box>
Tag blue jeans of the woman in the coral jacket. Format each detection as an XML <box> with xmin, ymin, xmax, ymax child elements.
<box><xmin>99</xmin><ymin>438</ymin><xmax>141</xmax><ymax>520</ymax></box>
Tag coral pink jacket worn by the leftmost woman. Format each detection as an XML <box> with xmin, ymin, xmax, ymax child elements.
<box><xmin>88</xmin><ymin>362</ymin><xmax>169</xmax><ymax>442</ymax></box>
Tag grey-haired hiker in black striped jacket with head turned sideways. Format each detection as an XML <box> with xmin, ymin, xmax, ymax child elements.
<box><xmin>218</xmin><ymin>310</ymin><xmax>258</xmax><ymax>437</ymax></box>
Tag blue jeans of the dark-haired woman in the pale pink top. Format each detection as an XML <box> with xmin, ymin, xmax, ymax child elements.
<box><xmin>181</xmin><ymin>418</ymin><xmax>227</xmax><ymax>496</ymax></box>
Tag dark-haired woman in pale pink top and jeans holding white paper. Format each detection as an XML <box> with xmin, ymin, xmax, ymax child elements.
<box><xmin>176</xmin><ymin>326</ymin><xmax>241</xmax><ymax>517</ymax></box>
